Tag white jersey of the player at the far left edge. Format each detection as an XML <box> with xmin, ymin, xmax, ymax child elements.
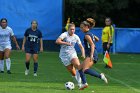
<box><xmin>0</xmin><ymin>26</ymin><xmax>14</xmax><ymax>46</ymax></box>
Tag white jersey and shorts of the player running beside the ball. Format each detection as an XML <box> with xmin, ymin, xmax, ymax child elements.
<box><xmin>59</xmin><ymin>32</ymin><xmax>81</xmax><ymax>66</ymax></box>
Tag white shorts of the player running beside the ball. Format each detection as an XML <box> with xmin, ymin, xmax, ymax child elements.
<box><xmin>59</xmin><ymin>52</ymin><xmax>78</xmax><ymax>66</ymax></box>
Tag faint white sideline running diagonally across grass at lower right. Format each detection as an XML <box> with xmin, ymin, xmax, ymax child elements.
<box><xmin>95</xmin><ymin>67</ymin><xmax>140</xmax><ymax>93</ymax></box>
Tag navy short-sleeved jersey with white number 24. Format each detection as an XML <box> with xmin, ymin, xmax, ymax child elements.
<box><xmin>24</xmin><ymin>28</ymin><xmax>42</xmax><ymax>51</ymax></box>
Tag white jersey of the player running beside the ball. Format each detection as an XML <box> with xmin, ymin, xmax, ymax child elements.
<box><xmin>59</xmin><ymin>32</ymin><xmax>81</xmax><ymax>54</ymax></box>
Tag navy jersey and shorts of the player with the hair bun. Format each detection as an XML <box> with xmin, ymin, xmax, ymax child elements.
<box><xmin>84</xmin><ymin>31</ymin><xmax>98</xmax><ymax>62</ymax></box>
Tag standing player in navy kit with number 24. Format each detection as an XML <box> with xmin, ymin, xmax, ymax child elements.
<box><xmin>22</xmin><ymin>21</ymin><xmax>43</xmax><ymax>76</ymax></box>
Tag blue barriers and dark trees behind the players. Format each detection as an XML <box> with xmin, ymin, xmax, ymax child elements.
<box><xmin>0</xmin><ymin>0</ymin><xmax>140</xmax><ymax>53</ymax></box>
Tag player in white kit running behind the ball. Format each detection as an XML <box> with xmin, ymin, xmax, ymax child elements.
<box><xmin>56</xmin><ymin>23</ymin><xmax>85</xmax><ymax>87</ymax></box>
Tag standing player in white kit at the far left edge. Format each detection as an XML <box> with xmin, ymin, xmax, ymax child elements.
<box><xmin>0</xmin><ymin>18</ymin><xmax>20</xmax><ymax>74</ymax></box>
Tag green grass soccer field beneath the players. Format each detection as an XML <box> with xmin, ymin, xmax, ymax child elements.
<box><xmin>0</xmin><ymin>51</ymin><xmax>140</xmax><ymax>93</ymax></box>
